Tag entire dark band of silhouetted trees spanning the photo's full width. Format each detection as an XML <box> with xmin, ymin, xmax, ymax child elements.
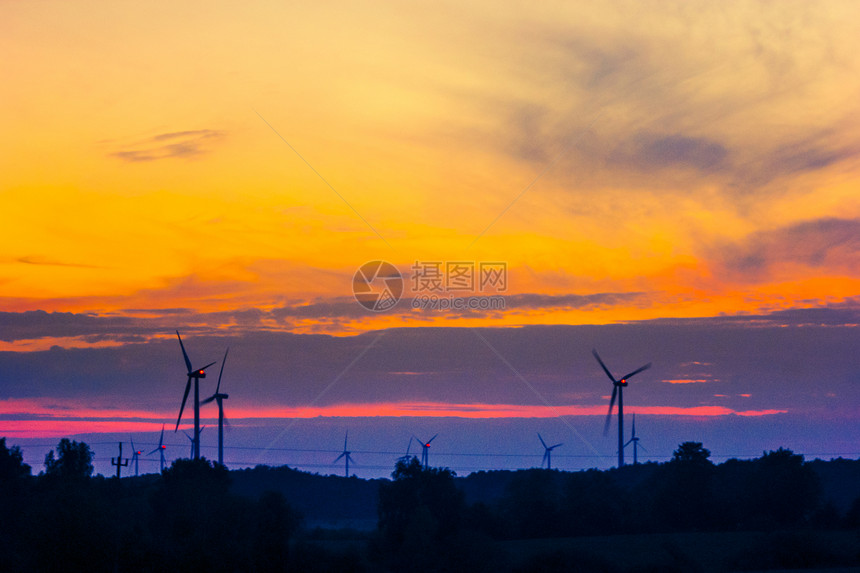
<box><xmin>0</xmin><ymin>439</ymin><xmax>860</xmax><ymax>573</ymax></box>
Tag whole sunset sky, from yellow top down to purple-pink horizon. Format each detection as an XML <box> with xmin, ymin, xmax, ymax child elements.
<box><xmin>0</xmin><ymin>0</ymin><xmax>860</xmax><ymax>475</ymax></box>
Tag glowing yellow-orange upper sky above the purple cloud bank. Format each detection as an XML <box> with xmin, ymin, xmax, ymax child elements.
<box><xmin>0</xmin><ymin>1</ymin><xmax>860</xmax><ymax>338</ymax></box>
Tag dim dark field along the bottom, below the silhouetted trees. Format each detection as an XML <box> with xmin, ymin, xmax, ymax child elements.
<box><xmin>293</xmin><ymin>530</ymin><xmax>860</xmax><ymax>573</ymax></box>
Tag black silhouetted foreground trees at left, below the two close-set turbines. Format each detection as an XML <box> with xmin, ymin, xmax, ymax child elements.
<box><xmin>0</xmin><ymin>439</ymin><xmax>298</xmax><ymax>571</ymax></box>
